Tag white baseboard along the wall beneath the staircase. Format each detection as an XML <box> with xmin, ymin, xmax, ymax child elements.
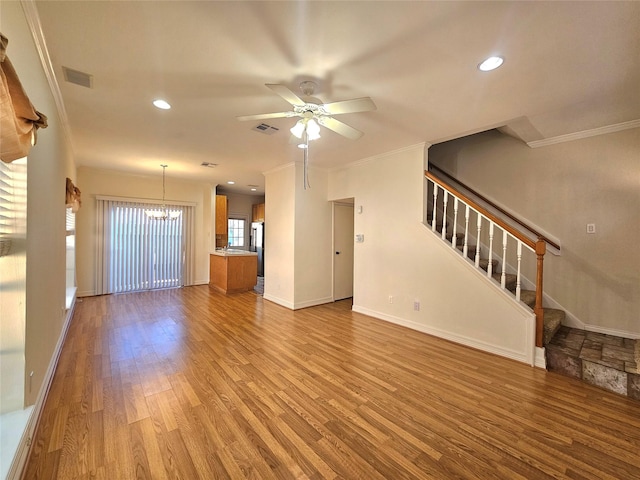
<box><xmin>352</xmin><ymin>304</ymin><xmax>533</xmax><ymax>365</ymax></box>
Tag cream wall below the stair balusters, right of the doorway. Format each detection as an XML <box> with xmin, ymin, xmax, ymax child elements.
<box><xmin>328</xmin><ymin>145</ymin><xmax>535</xmax><ymax>363</ymax></box>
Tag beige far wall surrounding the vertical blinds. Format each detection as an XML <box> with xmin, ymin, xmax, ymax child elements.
<box><xmin>76</xmin><ymin>167</ymin><xmax>212</xmax><ymax>296</ymax></box>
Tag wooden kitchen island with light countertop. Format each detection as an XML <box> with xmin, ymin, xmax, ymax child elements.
<box><xmin>209</xmin><ymin>249</ymin><xmax>258</xmax><ymax>293</ymax></box>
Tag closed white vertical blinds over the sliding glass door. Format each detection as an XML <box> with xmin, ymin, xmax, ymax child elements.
<box><xmin>96</xmin><ymin>197</ymin><xmax>194</xmax><ymax>294</ymax></box>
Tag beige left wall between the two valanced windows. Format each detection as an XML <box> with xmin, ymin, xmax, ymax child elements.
<box><xmin>0</xmin><ymin>2</ymin><xmax>75</xmax><ymax>405</ymax></box>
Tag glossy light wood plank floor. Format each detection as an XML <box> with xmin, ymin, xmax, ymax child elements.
<box><xmin>25</xmin><ymin>286</ymin><xmax>640</xmax><ymax>480</ymax></box>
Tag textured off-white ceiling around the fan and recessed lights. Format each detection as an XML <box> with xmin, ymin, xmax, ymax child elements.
<box><xmin>36</xmin><ymin>1</ymin><xmax>640</xmax><ymax>193</ymax></box>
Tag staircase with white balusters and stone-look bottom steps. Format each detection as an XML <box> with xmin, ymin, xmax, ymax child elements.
<box><xmin>425</xmin><ymin>172</ymin><xmax>640</xmax><ymax>400</ymax></box>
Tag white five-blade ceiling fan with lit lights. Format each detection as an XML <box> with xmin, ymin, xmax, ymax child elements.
<box><xmin>237</xmin><ymin>80</ymin><xmax>376</xmax><ymax>141</ymax></box>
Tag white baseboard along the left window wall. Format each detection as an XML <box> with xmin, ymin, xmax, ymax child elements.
<box><xmin>6</xmin><ymin>297</ymin><xmax>76</xmax><ymax>480</ymax></box>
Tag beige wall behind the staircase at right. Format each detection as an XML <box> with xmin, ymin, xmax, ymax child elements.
<box><xmin>429</xmin><ymin>128</ymin><xmax>640</xmax><ymax>336</ymax></box>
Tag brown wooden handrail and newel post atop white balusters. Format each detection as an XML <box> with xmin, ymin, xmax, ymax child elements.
<box><xmin>424</xmin><ymin>169</ymin><xmax>551</xmax><ymax>347</ymax></box>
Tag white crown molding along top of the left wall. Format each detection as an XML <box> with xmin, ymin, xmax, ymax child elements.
<box><xmin>20</xmin><ymin>0</ymin><xmax>74</xmax><ymax>152</ymax></box>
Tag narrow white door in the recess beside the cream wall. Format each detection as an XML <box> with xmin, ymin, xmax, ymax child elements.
<box><xmin>333</xmin><ymin>199</ymin><xmax>354</xmax><ymax>301</ymax></box>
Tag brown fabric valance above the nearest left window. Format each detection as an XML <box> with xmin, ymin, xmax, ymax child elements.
<box><xmin>0</xmin><ymin>33</ymin><xmax>47</xmax><ymax>163</ymax></box>
